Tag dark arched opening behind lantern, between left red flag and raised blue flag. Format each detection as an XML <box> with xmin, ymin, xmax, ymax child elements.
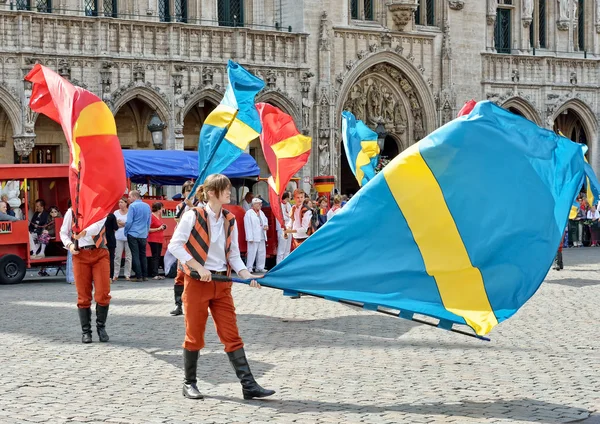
<box><xmin>115</xmin><ymin>98</ymin><xmax>166</xmax><ymax>149</ymax></box>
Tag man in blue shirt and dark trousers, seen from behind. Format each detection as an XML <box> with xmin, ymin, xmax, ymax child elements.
<box><xmin>124</xmin><ymin>190</ymin><xmax>152</xmax><ymax>281</ymax></box>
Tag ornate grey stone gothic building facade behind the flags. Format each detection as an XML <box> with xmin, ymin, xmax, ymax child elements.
<box><xmin>0</xmin><ymin>0</ymin><xmax>600</xmax><ymax>192</ymax></box>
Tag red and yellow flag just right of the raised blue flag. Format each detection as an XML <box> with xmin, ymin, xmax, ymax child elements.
<box><xmin>256</xmin><ymin>103</ymin><xmax>312</xmax><ymax>227</ymax></box>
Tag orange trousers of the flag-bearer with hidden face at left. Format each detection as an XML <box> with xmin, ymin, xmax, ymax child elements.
<box><xmin>73</xmin><ymin>249</ymin><xmax>111</xmax><ymax>308</ymax></box>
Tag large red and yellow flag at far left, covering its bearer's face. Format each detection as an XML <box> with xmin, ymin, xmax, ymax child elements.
<box><xmin>25</xmin><ymin>64</ymin><xmax>126</xmax><ymax>232</ymax></box>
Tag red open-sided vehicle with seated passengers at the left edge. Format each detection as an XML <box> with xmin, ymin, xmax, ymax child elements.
<box><xmin>0</xmin><ymin>165</ymin><xmax>69</xmax><ymax>284</ymax></box>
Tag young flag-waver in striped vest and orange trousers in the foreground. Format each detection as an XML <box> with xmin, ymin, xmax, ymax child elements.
<box><xmin>169</xmin><ymin>174</ymin><xmax>275</xmax><ymax>399</ymax></box>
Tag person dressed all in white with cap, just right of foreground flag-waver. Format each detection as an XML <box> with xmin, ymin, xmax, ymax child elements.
<box><xmin>244</xmin><ymin>197</ymin><xmax>269</xmax><ymax>272</ymax></box>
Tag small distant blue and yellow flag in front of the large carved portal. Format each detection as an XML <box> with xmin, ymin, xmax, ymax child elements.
<box><xmin>342</xmin><ymin>111</ymin><xmax>379</xmax><ymax>187</ymax></box>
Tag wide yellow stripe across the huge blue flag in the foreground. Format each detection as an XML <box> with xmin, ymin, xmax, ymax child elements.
<box><xmin>383</xmin><ymin>144</ymin><xmax>498</xmax><ymax>335</ymax></box>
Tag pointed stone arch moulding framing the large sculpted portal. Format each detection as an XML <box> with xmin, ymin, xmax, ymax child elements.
<box><xmin>335</xmin><ymin>51</ymin><xmax>437</xmax><ymax>136</ymax></box>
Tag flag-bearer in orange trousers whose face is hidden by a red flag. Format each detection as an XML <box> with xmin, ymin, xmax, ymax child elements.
<box><xmin>60</xmin><ymin>209</ymin><xmax>111</xmax><ymax>343</ymax></box>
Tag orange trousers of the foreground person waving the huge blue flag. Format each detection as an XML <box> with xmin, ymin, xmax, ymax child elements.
<box><xmin>182</xmin><ymin>275</ymin><xmax>244</xmax><ymax>352</ymax></box>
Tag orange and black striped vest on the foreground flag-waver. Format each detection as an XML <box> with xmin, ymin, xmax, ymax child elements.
<box><xmin>181</xmin><ymin>208</ymin><xmax>236</xmax><ymax>275</ymax></box>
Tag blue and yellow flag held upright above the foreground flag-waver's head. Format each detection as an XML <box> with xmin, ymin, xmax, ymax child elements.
<box><xmin>192</xmin><ymin>60</ymin><xmax>265</xmax><ymax>193</ymax></box>
